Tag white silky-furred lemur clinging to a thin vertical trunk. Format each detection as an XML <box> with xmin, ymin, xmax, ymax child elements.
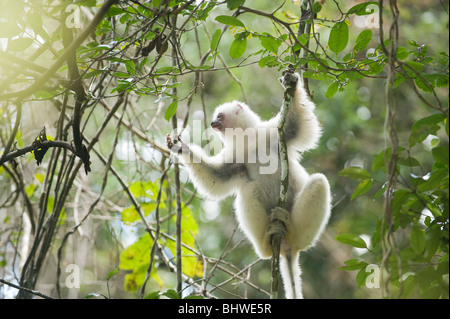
<box><xmin>167</xmin><ymin>72</ymin><xmax>330</xmax><ymax>298</ymax></box>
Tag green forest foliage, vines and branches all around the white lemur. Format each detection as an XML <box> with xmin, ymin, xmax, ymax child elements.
<box><xmin>0</xmin><ymin>0</ymin><xmax>449</xmax><ymax>298</ymax></box>
